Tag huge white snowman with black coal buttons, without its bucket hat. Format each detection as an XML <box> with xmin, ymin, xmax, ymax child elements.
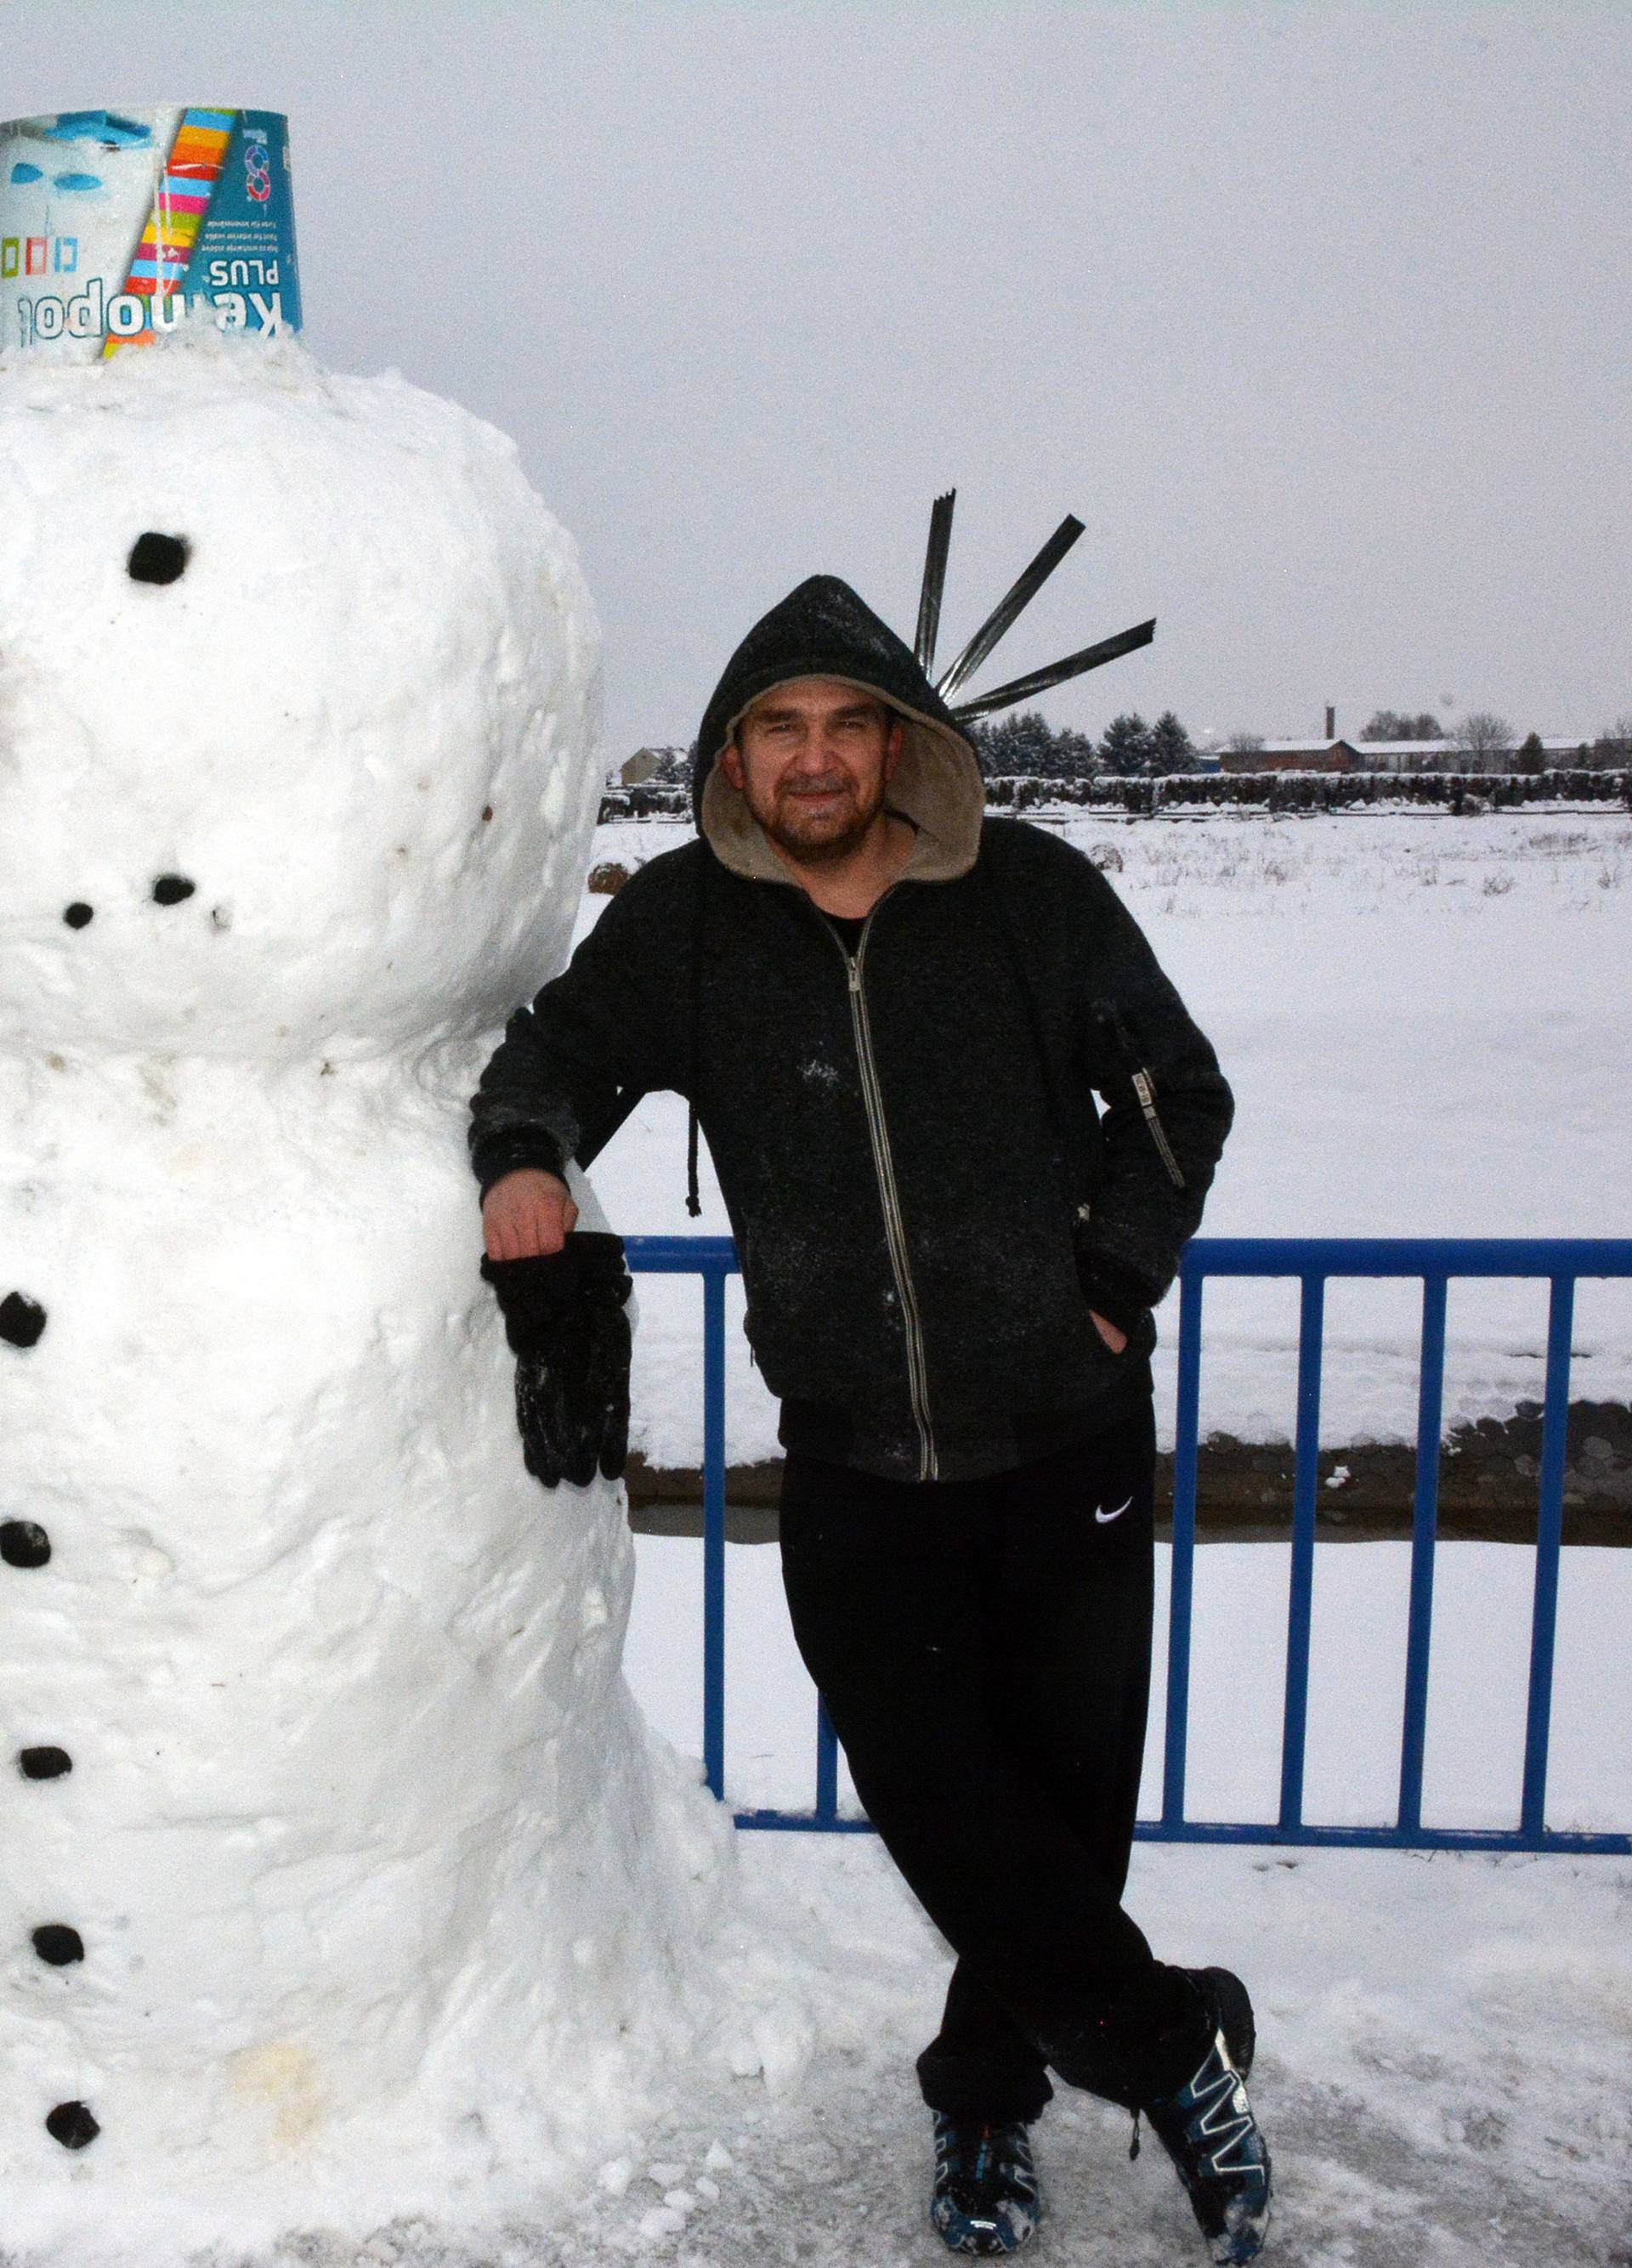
<box><xmin>0</xmin><ymin>331</ymin><xmax>780</xmax><ymax>2257</ymax></box>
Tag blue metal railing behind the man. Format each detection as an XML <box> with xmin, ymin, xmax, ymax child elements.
<box><xmin>626</xmin><ymin>1236</ymin><xmax>1632</xmax><ymax>1855</ymax></box>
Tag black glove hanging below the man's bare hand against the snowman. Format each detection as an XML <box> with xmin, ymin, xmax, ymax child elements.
<box><xmin>481</xmin><ymin>1230</ymin><xmax>633</xmax><ymax>1488</ymax></box>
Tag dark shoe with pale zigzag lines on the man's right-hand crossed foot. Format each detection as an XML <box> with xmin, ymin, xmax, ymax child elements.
<box><xmin>1140</xmin><ymin>1969</ymin><xmax>1269</xmax><ymax>2264</ymax></box>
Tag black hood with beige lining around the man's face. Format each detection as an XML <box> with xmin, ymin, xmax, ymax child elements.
<box><xmin>692</xmin><ymin>574</ymin><xmax>985</xmax><ymax>882</ymax></box>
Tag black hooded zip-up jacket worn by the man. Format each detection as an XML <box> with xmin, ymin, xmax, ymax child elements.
<box><xmin>470</xmin><ymin>576</ymin><xmax>1232</xmax><ymax>1481</ymax></box>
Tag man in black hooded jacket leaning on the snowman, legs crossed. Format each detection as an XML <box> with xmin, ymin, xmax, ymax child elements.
<box><xmin>470</xmin><ymin>576</ymin><xmax>1269</xmax><ymax>2261</ymax></box>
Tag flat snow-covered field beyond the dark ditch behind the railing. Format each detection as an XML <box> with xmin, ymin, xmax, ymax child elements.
<box><xmin>567</xmin><ymin>810</ymin><xmax>1632</xmax><ymax>1465</ymax></box>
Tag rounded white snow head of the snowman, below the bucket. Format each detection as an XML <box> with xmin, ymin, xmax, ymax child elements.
<box><xmin>0</xmin><ymin>331</ymin><xmax>599</xmax><ymax>1057</ymax></box>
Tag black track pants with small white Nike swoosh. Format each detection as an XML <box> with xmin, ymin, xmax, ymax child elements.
<box><xmin>781</xmin><ymin>1401</ymin><xmax>1194</xmax><ymax>2123</ymax></box>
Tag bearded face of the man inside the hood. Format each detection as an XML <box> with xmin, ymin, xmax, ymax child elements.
<box><xmin>720</xmin><ymin>678</ymin><xmax>901</xmax><ymax>867</ymax></box>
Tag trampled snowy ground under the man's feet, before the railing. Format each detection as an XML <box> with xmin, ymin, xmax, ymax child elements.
<box><xmin>172</xmin><ymin>1835</ymin><xmax>1632</xmax><ymax>2268</ymax></box>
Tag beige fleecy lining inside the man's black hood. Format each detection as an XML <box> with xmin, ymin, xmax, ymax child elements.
<box><xmin>701</xmin><ymin>671</ymin><xmax>985</xmax><ymax>887</ymax></box>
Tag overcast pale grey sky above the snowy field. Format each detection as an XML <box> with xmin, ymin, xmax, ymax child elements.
<box><xmin>13</xmin><ymin>0</ymin><xmax>1632</xmax><ymax>755</ymax></box>
